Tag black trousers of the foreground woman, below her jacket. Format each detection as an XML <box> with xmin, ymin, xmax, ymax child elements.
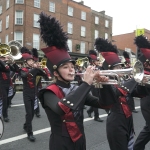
<box><xmin>49</xmin><ymin>133</ymin><xmax>86</xmax><ymax>150</ymax></box>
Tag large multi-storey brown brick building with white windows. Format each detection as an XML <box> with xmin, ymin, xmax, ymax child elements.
<box><xmin>0</xmin><ymin>0</ymin><xmax>112</xmax><ymax>56</ymax></box>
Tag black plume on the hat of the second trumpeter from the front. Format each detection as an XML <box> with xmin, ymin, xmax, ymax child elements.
<box><xmin>94</xmin><ymin>38</ymin><xmax>118</xmax><ymax>53</ymax></box>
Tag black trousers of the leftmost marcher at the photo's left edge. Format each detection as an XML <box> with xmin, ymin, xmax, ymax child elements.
<box><xmin>0</xmin><ymin>85</ymin><xmax>9</xmax><ymax>118</ymax></box>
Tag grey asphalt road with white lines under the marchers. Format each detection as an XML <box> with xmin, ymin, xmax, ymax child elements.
<box><xmin>0</xmin><ymin>92</ymin><xmax>150</xmax><ymax>150</ymax></box>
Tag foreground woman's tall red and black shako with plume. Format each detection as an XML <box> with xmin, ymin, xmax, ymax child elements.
<box><xmin>38</xmin><ymin>12</ymin><xmax>75</xmax><ymax>74</ymax></box>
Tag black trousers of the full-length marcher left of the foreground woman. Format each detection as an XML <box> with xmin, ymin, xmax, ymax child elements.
<box><xmin>23</xmin><ymin>92</ymin><xmax>35</xmax><ymax>135</ymax></box>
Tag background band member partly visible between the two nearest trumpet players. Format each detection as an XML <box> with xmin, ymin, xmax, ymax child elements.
<box><xmin>87</xmin><ymin>50</ymin><xmax>103</xmax><ymax>122</ymax></box>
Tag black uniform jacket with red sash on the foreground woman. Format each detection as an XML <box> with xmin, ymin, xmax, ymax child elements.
<box><xmin>39</xmin><ymin>80</ymin><xmax>116</xmax><ymax>142</ymax></box>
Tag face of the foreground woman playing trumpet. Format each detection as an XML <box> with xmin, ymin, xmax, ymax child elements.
<box><xmin>54</xmin><ymin>62</ymin><xmax>75</xmax><ymax>81</ymax></box>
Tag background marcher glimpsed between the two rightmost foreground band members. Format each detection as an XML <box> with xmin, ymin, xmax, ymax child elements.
<box><xmin>123</xmin><ymin>51</ymin><xmax>138</xmax><ymax>113</ymax></box>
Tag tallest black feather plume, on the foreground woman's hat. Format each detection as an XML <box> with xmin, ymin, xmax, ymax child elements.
<box><xmin>38</xmin><ymin>12</ymin><xmax>68</xmax><ymax>51</ymax></box>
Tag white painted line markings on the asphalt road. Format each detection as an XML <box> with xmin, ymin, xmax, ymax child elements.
<box><xmin>0</xmin><ymin>104</ymin><xmax>140</xmax><ymax>145</ymax></box>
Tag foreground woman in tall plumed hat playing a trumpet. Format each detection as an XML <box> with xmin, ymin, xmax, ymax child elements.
<box><xmin>39</xmin><ymin>13</ymin><xmax>115</xmax><ymax>150</ymax></box>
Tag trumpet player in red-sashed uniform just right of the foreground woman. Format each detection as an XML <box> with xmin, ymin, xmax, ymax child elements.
<box><xmin>95</xmin><ymin>38</ymin><xmax>148</xmax><ymax>150</ymax></box>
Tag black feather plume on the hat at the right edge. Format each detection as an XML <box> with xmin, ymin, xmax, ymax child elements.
<box><xmin>134</xmin><ymin>35</ymin><xmax>150</xmax><ymax>48</ymax></box>
